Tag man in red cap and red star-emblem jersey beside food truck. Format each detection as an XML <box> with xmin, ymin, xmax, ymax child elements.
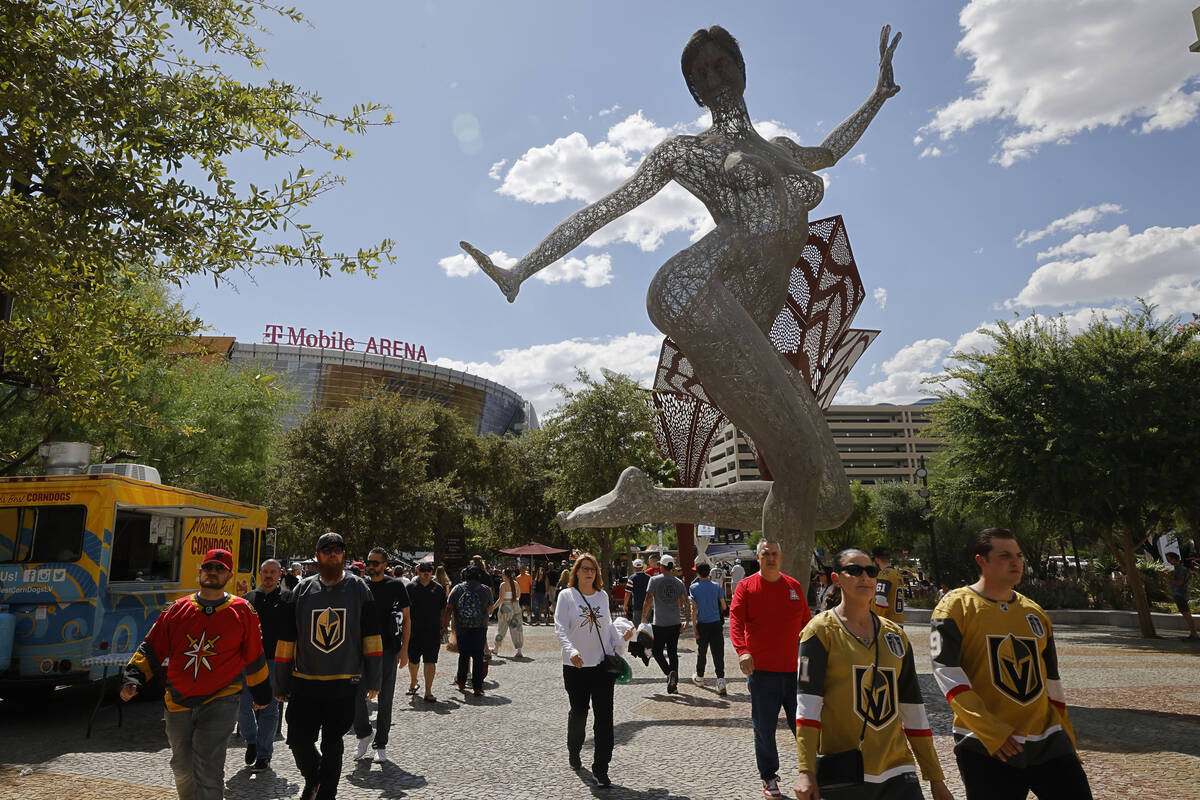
<box><xmin>121</xmin><ymin>549</ymin><xmax>271</xmax><ymax>800</ymax></box>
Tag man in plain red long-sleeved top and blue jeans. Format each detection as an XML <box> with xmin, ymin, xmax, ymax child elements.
<box><xmin>730</xmin><ymin>539</ymin><xmax>812</xmax><ymax>798</ymax></box>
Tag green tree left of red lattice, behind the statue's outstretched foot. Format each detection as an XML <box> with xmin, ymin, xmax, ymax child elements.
<box><xmin>544</xmin><ymin>369</ymin><xmax>664</xmax><ymax>575</ymax></box>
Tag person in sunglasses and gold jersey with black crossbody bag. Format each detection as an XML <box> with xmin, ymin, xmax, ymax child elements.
<box><xmin>794</xmin><ymin>549</ymin><xmax>953</xmax><ymax>800</ymax></box>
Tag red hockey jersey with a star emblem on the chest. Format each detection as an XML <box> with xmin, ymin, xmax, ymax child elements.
<box><xmin>125</xmin><ymin>594</ymin><xmax>271</xmax><ymax>711</ymax></box>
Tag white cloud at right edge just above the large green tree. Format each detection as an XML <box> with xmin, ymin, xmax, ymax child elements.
<box><xmin>1004</xmin><ymin>224</ymin><xmax>1200</xmax><ymax>313</ymax></box>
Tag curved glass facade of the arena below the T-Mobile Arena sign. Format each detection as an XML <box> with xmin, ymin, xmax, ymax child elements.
<box><xmin>229</xmin><ymin>342</ymin><xmax>538</xmax><ymax>437</ymax></box>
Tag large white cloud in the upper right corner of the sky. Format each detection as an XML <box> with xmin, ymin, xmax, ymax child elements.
<box><xmin>922</xmin><ymin>0</ymin><xmax>1200</xmax><ymax>167</ymax></box>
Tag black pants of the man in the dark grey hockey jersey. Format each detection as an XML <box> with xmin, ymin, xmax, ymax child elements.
<box><xmin>287</xmin><ymin>680</ymin><xmax>359</xmax><ymax>800</ymax></box>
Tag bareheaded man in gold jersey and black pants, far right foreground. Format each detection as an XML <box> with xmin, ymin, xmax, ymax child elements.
<box><xmin>929</xmin><ymin>528</ymin><xmax>1092</xmax><ymax>800</ymax></box>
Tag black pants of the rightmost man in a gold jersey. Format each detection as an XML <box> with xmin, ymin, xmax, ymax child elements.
<box><xmin>954</xmin><ymin>750</ymin><xmax>1092</xmax><ymax>800</ymax></box>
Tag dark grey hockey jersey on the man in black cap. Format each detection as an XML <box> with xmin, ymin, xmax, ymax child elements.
<box><xmin>275</xmin><ymin>573</ymin><xmax>383</xmax><ymax>697</ymax></box>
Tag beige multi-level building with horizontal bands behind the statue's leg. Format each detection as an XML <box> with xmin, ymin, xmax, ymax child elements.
<box><xmin>701</xmin><ymin>399</ymin><xmax>940</xmax><ymax>487</ymax></box>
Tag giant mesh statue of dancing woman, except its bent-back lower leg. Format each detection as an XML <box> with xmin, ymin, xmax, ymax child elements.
<box><xmin>461</xmin><ymin>25</ymin><xmax>900</xmax><ymax>581</ymax></box>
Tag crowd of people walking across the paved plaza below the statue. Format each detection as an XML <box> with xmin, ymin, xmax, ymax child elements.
<box><xmin>121</xmin><ymin>529</ymin><xmax>1091</xmax><ymax>800</ymax></box>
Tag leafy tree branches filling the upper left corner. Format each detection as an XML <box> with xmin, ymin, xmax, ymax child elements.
<box><xmin>0</xmin><ymin>0</ymin><xmax>392</xmax><ymax>431</ymax></box>
